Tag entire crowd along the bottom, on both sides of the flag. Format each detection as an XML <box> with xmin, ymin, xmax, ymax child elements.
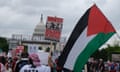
<box><xmin>0</xmin><ymin>52</ymin><xmax>120</xmax><ymax>72</ymax></box>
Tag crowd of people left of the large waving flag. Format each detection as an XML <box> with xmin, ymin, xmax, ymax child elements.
<box><xmin>0</xmin><ymin>52</ymin><xmax>56</xmax><ymax>72</ymax></box>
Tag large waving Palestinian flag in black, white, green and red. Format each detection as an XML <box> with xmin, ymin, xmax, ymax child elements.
<box><xmin>58</xmin><ymin>5</ymin><xmax>115</xmax><ymax>72</ymax></box>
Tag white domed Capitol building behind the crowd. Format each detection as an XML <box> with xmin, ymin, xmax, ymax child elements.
<box><xmin>8</xmin><ymin>14</ymin><xmax>66</xmax><ymax>51</ymax></box>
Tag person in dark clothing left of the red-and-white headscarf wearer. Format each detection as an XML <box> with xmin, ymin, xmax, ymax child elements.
<box><xmin>14</xmin><ymin>52</ymin><xmax>29</xmax><ymax>72</ymax></box>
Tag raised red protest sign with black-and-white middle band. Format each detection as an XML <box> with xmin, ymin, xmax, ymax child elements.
<box><xmin>45</xmin><ymin>16</ymin><xmax>63</xmax><ymax>41</ymax></box>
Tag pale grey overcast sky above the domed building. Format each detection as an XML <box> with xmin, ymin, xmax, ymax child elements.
<box><xmin>0</xmin><ymin>0</ymin><xmax>120</xmax><ymax>43</ymax></box>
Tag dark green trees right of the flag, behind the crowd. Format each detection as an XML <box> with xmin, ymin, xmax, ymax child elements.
<box><xmin>92</xmin><ymin>44</ymin><xmax>120</xmax><ymax>61</ymax></box>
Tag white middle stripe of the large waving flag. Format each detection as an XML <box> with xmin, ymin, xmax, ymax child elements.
<box><xmin>64</xmin><ymin>28</ymin><xmax>96</xmax><ymax>70</ymax></box>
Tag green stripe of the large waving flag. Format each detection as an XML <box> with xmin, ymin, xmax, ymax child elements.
<box><xmin>73</xmin><ymin>32</ymin><xmax>114</xmax><ymax>72</ymax></box>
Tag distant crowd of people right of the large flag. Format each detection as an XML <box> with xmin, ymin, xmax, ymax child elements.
<box><xmin>85</xmin><ymin>58</ymin><xmax>120</xmax><ymax>72</ymax></box>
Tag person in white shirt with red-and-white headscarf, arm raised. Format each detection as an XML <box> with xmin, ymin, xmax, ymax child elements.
<box><xmin>20</xmin><ymin>53</ymin><xmax>53</xmax><ymax>72</ymax></box>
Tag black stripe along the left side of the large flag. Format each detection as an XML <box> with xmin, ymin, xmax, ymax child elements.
<box><xmin>58</xmin><ymin>8</ymin><xmax>91</xmax><ymax>67</ymax></box>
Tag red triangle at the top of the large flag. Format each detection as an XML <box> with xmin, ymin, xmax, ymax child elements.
<box><xmin>87</xmin><ymin>5</ymin><xmax>115</xmax><ymax>36</ymax></box>
